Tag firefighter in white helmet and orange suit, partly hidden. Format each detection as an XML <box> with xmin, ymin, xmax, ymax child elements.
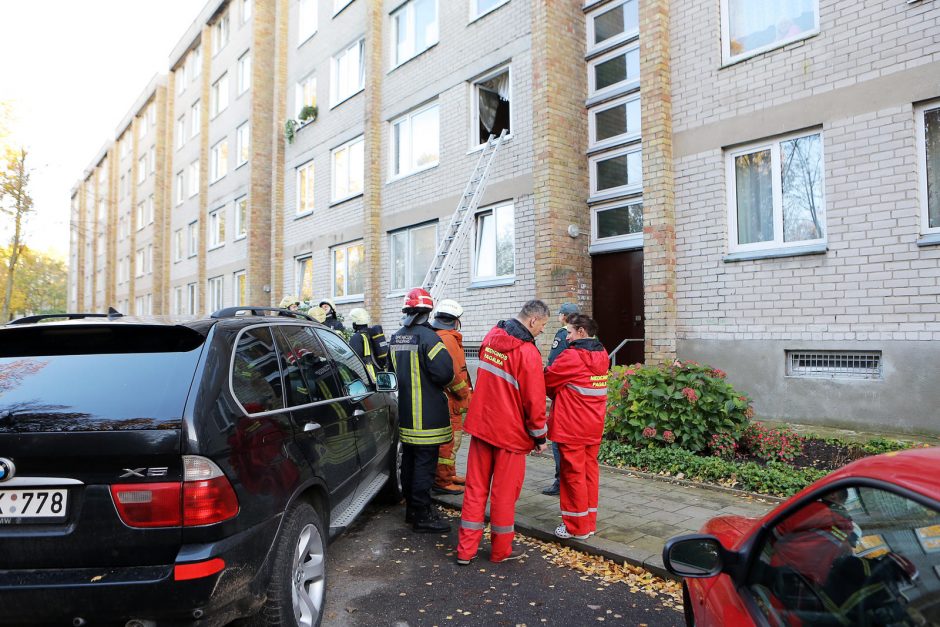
<box><xmin>431</xmin><ymin>299</ymin><xmax>473</xmax><ymax>494</ymax></box>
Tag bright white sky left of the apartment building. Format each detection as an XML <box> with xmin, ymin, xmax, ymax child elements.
<box><xmin>0</xmin><ymin>0</ymin><xmax>205</xmax><ymax>259</ymax></box>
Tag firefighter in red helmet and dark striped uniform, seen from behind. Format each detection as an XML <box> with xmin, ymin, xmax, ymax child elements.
<box><xmin>389</xmin><ymin>288</ymin><xmax>454</xmax><ymax>533</ymax></box>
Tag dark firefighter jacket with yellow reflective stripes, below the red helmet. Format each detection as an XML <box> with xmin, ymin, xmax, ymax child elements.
<box><xmin>389</xmin><ymin>323</ymin><xmax>454</xmax><ymax>445</ymax></box>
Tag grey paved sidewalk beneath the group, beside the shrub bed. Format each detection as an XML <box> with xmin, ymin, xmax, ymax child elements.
<box><xmin>433</xmin><ymin>437</ymin><xmax>779</xmax><ymax>578</ymax></box>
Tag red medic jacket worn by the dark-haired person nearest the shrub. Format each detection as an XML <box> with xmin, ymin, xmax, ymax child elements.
<box><xmin>545</xmin><ymin>338</ymin><xmax>610</xmax><ymax>446</ymax></box>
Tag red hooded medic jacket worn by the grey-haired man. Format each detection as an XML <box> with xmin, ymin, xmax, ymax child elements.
<box><xmin>464</xmin><ymin>320</ymin><xmax>546</xmax><ymax>453</ymax></box>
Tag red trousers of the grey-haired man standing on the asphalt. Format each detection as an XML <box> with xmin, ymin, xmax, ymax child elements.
<box><xmin>457</xmin><ymin>438</ymin><xmax>526</xmax><ymax>562</ymax></box>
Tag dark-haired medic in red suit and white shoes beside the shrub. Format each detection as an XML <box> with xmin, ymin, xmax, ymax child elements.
<box><xmin>545</xmin><ymin>314</ymin><xmax>610</xmax><ymax>540</ymax></box>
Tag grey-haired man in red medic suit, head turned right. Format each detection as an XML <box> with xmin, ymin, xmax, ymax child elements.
<box><xmin>457</xmin><ymin>300</ymin><xmax>551</xmax><ymax>565</ymax></box>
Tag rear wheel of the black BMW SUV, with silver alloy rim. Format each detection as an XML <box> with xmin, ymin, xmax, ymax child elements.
<box><xmin>251</xmin><ymin>502</ymin><xmax>329</xmax><ymax>627</ymax></box>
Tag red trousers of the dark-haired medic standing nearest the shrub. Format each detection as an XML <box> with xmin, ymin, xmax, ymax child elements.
<box><xmin>558</xmin><ymin>442</ymin><xmax>600</xmax><ymax>536</ymax></box>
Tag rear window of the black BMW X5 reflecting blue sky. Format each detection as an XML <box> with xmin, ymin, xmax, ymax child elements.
<box><xmin>0</xmin><ymin>325</ymin><xmax>205</xmax><ymax>433</ymax></box>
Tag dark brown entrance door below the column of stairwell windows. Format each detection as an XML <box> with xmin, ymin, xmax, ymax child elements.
<box><xmin>591</xmin><ymin>250</ymin><xmax>644</xmax><ymax>365</ymax></box>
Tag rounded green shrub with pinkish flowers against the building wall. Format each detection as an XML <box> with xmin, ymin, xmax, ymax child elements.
<box><xmin>604</xmin><ymin>361</ymin><xmax>753</xmax><ymax>451</ymax></box>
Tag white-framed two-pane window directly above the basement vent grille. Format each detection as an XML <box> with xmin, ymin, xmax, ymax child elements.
<box><xmin>727</xmin><ymin>133</ymin><xmax>826</xmax><ymax>252</ymax></box>
